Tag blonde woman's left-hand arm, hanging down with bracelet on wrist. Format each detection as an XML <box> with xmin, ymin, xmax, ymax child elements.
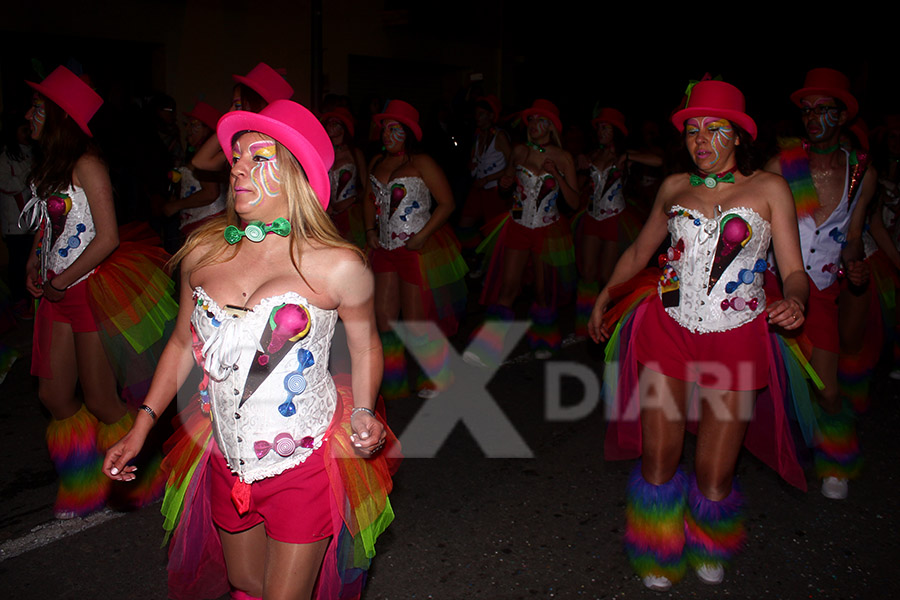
<box><xmin>103</xmin><ymin>257</ymin><xmax>202</xmax><ymax>481</ymax></box>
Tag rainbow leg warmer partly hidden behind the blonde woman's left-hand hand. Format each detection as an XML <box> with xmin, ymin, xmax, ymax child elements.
<box><xmin>97</xmin><ymin>412</ymin><xmax>167</xmax><ymax>509</ymax></box>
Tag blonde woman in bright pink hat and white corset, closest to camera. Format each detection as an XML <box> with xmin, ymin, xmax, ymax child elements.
<box><xmin>104</xmin><ymin>100</ymin><xmax>397</xmax><ymax>600</ymax></box>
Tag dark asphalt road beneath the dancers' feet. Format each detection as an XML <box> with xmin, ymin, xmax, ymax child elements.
<box><xmin>0</xmin><ymin>304</ymin><xmax>900</xmax><ymax>600</ymax></box>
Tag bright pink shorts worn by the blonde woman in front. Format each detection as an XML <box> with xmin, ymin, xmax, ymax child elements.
<box><xmin>210</xmin><ymin>442</ymin><xmax>332</xmax><ymax>544</ymax></box>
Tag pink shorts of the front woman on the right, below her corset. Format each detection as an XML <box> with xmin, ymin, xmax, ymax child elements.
<box><xmin>634</xmin><ymin>296</ymin><xmax>769</xmax><ymax>391</ymax></box>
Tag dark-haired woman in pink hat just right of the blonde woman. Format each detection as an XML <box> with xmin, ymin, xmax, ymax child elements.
<box><xmin>363</xmin><ymin>100</ymin><xmax>466</xmax><ymax>398</ymax></box>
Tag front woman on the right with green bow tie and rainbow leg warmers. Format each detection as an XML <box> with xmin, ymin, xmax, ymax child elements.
<box><xmin>589</xmin><ymin>81</ymin><xmax>811</xmax><ymax>590</ymax></box>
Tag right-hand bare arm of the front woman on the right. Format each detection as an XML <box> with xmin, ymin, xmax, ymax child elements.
<box><xmin>758</xmin><ymin>173</ymin><xmax>809</xmax><ymax>329</ymax></box>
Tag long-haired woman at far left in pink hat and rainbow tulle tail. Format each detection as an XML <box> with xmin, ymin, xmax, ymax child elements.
<box><xmin>22</xmin><ymin>67</ymin><xmax>174</xmax><ymax>519</ymax></box>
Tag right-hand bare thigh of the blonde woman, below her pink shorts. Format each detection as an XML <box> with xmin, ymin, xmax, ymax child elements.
<box><xmin>263</xmin><ymin>538</ymin><xmax>331</xmax><ymax>600</ymax></box>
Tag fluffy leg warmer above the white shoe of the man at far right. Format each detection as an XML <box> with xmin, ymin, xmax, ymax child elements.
<box><xmin>815</xmin><ymin>404</ymin><xmax>862</xmax><ymax>479</ymax></box>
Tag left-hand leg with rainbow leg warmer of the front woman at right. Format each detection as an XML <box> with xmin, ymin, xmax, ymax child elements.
<box><xmin>625</xmin><ymin>367</ymin><xmax>687</xmax><ymax>590</ymax></box>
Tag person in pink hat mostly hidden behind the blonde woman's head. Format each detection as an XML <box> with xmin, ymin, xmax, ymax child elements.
<box><xmin>191</xmin><ymin>63</ymin><xmax>294</xmax><ymax>171</ymax></box>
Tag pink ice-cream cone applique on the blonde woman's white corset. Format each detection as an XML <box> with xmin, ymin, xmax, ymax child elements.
<box><xmin>238</xmin><ymin>304</ymin><xmax>315</xmax><ymax>407</ymax></box>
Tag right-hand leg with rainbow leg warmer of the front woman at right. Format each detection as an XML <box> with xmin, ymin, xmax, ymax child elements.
<box><xmin>685</xmin><ymin>389</ymin><xmax>756</xmax><ymax>584</ymax></box>
